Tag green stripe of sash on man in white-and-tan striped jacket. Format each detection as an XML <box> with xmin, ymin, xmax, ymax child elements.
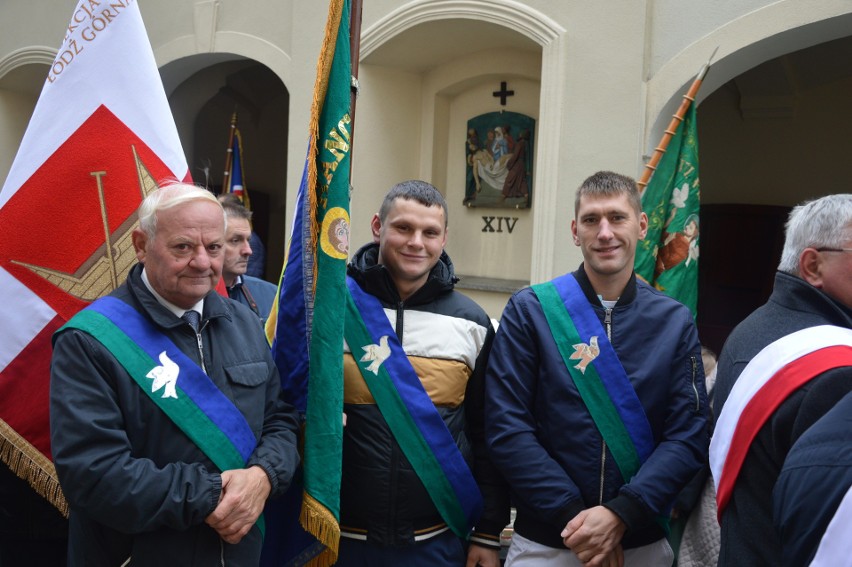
<box><xmin>344</xmin><ymin>293</ymin><xmax>472</xmax><ymax>537</ymax></box>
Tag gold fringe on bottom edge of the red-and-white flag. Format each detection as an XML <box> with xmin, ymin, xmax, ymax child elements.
<box><xmin>0</xmin><ymin>419</ymin><xmax>68</xmax><ymax>518</ymax></box>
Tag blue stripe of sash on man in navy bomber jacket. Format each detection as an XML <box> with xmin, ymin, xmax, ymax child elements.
<box><xmin>553</xmin><ymin>273</ymin><xmax>654</xmax><ymax>463</ymax></box>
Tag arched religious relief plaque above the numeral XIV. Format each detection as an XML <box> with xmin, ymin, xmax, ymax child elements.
<box><xmin>463</xmin><ymin>111</ymin><xmax>535</xmax><ymax>209</ymax></box>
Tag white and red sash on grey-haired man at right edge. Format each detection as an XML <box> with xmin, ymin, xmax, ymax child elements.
<box><xmin>710</xmin><ymin>325</ymin><xmax>852</xmax><ymax>517</ymax></box>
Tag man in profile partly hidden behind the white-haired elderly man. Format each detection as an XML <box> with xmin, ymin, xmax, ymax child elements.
<box><xmin>219</xmin><ymin>194</ymin><xmax>278</xmax><ymax>323</ymax></box>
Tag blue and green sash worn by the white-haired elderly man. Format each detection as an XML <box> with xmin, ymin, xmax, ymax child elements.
<box><xmin>60</xmin><ymin>297</ymin><xmax>263</xmax><ymax>532</ymax></box>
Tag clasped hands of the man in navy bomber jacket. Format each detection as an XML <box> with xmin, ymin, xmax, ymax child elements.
<box><xmin>561</xmin><ymin>506</ymin><xmax>625</xmax><ymax>567</ymax></box>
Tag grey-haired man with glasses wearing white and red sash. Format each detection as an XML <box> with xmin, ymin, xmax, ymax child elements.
<box><xmin>710</xmin><ymin>194</ymin><xmax>852</xmax><ymax>566</ymax></box>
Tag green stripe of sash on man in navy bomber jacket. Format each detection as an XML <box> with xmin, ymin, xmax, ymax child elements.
<box><xmin>532</xmin><ymin>282</ymin><xmax>641</xmax><ymax>482</ymax></box>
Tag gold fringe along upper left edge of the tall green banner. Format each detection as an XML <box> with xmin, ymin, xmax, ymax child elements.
<box><xmin>305</xmin><ymin>0</ymin><xmax>344</xmax><ymax>294</ymax></box>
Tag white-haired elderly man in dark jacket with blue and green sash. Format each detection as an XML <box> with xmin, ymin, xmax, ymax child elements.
<box><xmin>50</xmin><ymin>184</ymin><xmax>299</xmax><ymax>567</ymax></box>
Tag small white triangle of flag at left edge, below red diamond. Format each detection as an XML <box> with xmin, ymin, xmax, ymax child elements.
<box><xmin>0</xmin><ymin>268</ymin><xmax>56</xmax><ymax>372</ymax></box>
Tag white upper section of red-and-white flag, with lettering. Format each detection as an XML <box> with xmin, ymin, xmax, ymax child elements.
<box><xmin>0</xmin><ymin>0</ymin><xmax>187</xmax><ymax>207</ymax></box>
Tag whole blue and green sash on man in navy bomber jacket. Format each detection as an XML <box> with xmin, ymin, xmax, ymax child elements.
<box><xmin>532</xmin><ymin>274</ymin><xmax>654</xmax><ymax>482</ymax></box>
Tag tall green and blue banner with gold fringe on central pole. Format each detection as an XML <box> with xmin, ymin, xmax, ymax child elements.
<box><xmin>262</xmin><ymin>0</ymin><xmax>352</xmax><ymax>566</ymax></box>
